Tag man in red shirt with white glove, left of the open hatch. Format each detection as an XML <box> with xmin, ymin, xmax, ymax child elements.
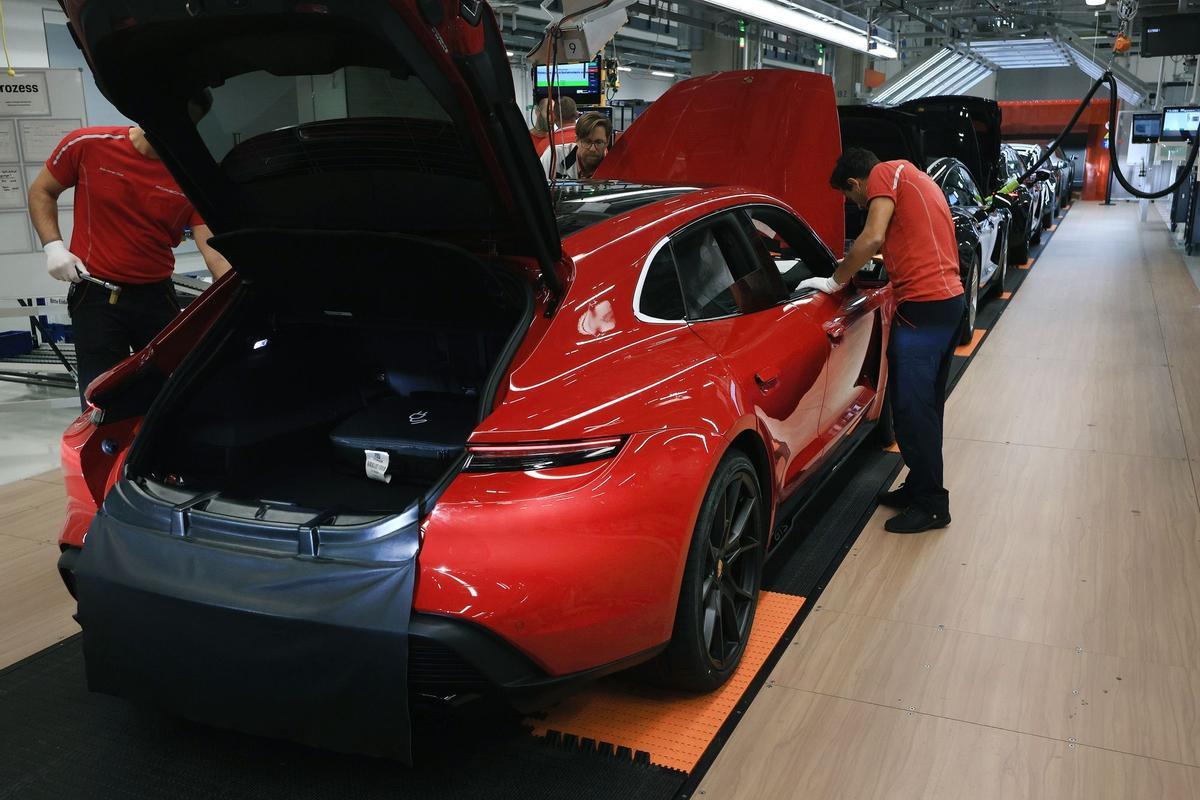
<box><xmin>29</xmin><ymin>94</ymin><xmax>229</xmax><ymax>405</ymax></box>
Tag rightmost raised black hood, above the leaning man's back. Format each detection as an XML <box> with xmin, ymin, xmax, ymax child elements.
<box><xmin>896</xmin><ymin>95</ymin><xmax>1000</xmax><ymax>193</ymax></box>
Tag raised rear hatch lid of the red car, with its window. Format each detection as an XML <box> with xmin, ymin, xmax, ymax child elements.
<box><xmin>61</xmin><ymin>0</ymin><xmax>560</xmax><ymax>287</ymax></box>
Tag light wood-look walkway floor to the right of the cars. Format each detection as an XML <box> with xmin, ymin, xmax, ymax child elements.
<box><xmin>697</xmin><ymin>203</ymin><xmax>1200</xmax><ymax>800</ymax></box>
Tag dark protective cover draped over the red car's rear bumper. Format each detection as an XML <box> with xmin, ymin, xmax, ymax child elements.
<box><xmin>76</xmin><ymin>494</ymin><xmax>418</xmax><ymax>762</ymax></box>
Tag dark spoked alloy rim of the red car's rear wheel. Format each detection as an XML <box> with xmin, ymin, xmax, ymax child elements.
<box><xmin>700</xmin><ymin>473</ymin><xmax>762</xmax><ymax>669</ymax></box>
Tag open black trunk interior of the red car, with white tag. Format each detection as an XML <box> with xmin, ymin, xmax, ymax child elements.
<box><xmin>128</xmin><ymin>235</ymin><xmax>532</xmax><ymax>518</ymax></box>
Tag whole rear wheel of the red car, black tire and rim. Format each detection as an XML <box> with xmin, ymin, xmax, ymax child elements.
<box><xmin>654</xmin><ymin>450</ymin><xmax>768</xmax><ymax>692</ymax></box>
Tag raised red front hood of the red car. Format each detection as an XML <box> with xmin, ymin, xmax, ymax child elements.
<box><xmin>595</xmin><ymin>70</ymin><xmax>845</xmax><ymax>253</ymax></box>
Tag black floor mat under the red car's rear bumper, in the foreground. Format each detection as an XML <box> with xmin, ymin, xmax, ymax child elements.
<box><xmin>0</xmin><ymin>637</ymin><xmax>685</xmax><ymax>800</ymax></box>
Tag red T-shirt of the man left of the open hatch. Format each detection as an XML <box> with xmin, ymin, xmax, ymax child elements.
<box><xmin>46</xmin><ymin>126</ymin><xmax>204</xmax><ymax>283</ymax></box>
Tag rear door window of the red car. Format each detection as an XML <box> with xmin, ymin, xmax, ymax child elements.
<box><xmin>671</xmin><ymin>215</ymin><xmax>781</xmax><ymax>320</ymax></box>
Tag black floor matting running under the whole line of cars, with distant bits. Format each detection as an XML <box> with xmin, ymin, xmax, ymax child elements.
<box><xmin>0</xmin><ymin>208</ymin><xmax>1070</xmax><ymax>800</ymax></box>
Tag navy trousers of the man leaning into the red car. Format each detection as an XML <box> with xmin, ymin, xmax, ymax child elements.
<box><xmin>888</xmin><ymin>295</ymin><xmax>964</xmax><ymax>513</ymax></box>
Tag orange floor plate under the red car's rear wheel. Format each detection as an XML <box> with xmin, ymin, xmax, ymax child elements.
<box><xmin>529</xmin><ymin>591</ymin><xmax>804</xmax><ymax>772</ymax></box>
